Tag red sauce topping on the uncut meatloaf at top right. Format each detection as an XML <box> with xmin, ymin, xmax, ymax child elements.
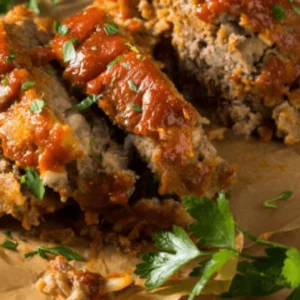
<box><xmin>197</xmin><ymin>0</ymin><xmax>300</xmax><ymax>59</ymax></box>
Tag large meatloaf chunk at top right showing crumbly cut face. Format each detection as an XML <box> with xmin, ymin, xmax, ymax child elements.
<box><xmin>115</xmin><ymin>0</ymin><xmax>300</xmax><ymax>144</ymax></box>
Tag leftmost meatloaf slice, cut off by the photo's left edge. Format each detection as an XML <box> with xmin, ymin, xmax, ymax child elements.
<box><xmin>0</xmin><ymin>7</ymin><xmax>135</xmax><ymax>225</ymax></box>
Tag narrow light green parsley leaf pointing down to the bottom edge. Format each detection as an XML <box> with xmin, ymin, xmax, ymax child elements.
<box><xmin>189</xmin><ymin>249</ymin><xmax>238</xmax><ymax>300</ymax></box>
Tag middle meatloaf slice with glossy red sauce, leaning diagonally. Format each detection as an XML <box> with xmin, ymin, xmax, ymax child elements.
<box><xmin>51</xmin><ymin>6</ymin><xmax>234</xmax><ymax>196</ymax></box>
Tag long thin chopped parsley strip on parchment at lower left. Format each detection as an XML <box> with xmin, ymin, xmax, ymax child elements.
<box><xmin>24</xmin><ymin>246</ymin><xmax>83</xmax><ymax>261</ymax></box>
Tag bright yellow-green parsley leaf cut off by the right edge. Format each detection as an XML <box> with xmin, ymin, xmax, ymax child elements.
<box><xmin>282</xmin><ymin>248</ymin><xmax>300</xmax><ymax>289</ymax></box>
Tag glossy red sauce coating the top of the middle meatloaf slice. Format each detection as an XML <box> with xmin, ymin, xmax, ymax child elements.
<box><xmin>52</xmin><ymin>8</ymin><xmax>234</xmax><ymax>195</ymax></box>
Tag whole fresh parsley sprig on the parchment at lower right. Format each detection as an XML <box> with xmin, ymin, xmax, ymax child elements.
<box><xmin>135</xmin><ymin>193</ymin><xmax>300</xmax><ymax>300</ymax></box>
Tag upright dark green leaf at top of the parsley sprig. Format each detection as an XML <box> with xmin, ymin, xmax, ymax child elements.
<box><xmin>183</xmin><ymin>193</ymin><xmax>235</xmax><ymax>249</ymax></box>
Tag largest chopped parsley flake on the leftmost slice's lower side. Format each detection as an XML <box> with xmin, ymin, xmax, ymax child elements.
<box><xmin>21</xmin><ymin>167</ymin><xmax>45</xmax><ymax>200</ymax></box>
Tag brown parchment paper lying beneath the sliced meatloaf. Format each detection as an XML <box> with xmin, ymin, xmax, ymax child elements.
<box><xmin>0</xmin><ymin>0</ymin><xmax>300</xmax><ymax>300</ymax></box>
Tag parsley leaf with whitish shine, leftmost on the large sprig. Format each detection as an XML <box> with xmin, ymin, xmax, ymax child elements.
<box><xmin>135</xmin><ymin>226</ymin><xmax>201</xmax><ymax>290</ymax></box>
